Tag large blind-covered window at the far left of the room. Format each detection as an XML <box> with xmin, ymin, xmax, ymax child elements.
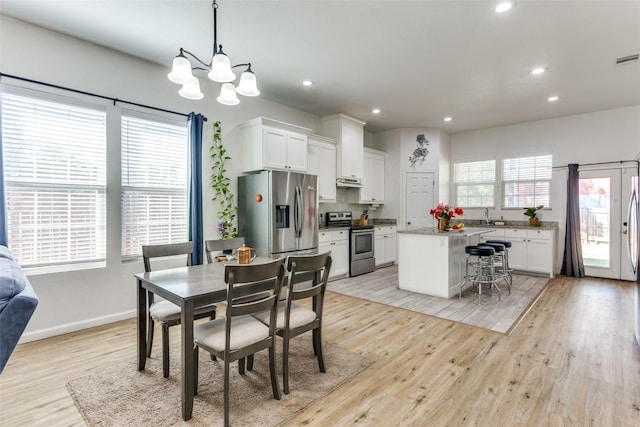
<box><xmin>2</xmin><ymin>93</ymin><xmax>106</xmax><ymax>267</ymax></box>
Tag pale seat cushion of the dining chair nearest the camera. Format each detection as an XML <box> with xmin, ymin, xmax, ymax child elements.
<box><xmin>193</xmin><ymin>316</ymin><xmax>269</xmax><ymax>352</ymax></box>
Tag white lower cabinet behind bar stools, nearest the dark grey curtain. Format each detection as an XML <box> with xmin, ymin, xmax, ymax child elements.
<box><xmin>504</xmin><ymin>228</ymin><xmax>555</xmax><ymax>277</ymax></box>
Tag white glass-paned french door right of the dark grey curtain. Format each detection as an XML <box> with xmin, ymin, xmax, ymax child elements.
<box><xmin>580</xmin><ymin>167</ymin><xmax>638</xmax><ymax>280</ymax></box>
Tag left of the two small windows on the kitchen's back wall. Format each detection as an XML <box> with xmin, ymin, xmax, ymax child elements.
<box><xmin>453</xmin><ymin>160</ymin><xmax>496</xmax><ymax>208</ymax></box>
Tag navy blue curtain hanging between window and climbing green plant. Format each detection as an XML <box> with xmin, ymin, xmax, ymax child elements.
<box><xmin>189</xmin><ymin>113</ymin><xmax>206</xmax><ymax>265</ymax></box>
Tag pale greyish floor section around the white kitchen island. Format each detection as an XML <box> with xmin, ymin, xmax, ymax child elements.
<box><xmin>327</xmin><ymin>266</ymin><xmax>549</xmax><ymax>334</ymax></box>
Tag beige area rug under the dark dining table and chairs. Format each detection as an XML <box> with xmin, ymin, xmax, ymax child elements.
<box><xmin>67</xmin><ymin>340</ymin><xmax>373</xmax><ymax>427</ymax></box>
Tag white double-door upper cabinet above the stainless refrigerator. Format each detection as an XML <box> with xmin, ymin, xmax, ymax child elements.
<box><xmin>240</xmin><ymin>117</ymin><xmax>311</xmax><ymax>172</ymax></box>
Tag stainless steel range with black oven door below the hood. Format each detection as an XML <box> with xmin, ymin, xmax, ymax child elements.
<box><xmin>325</xmin><ymin>212</ymin><xmax>376</xmax><ymax>276</ymax></box>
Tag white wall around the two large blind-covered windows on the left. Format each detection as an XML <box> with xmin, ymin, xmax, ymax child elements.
<box><xmin>0</xmin><ymin>16</ymin><xmax>320</xmax><ymax>341</ymax></box>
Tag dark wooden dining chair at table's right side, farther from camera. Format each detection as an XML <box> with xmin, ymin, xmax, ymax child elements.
<box><xmin>249</xmin><ymin>253</ymin><xmax>331</xmax><ymax>394</ymax></box>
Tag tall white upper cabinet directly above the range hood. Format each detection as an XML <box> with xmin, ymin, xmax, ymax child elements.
<box><xmin>322</xmin><ymin>114</ymin><xmax>366</xmax><ymax>179</ymax></box>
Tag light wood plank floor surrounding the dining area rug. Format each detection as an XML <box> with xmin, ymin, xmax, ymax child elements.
<box><xmin>0</xmin><ymin>277</ymin><xmax>640</xmax><ymax>426</ymax></box>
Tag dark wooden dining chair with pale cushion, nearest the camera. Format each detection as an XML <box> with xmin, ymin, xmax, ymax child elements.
<box><xmin>193</xmin><ymin>258</ymin><xmax>285</xmax><ymax>426</ymax></box>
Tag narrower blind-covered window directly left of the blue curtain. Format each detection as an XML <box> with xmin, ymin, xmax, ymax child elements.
<box><xmin>121</xmin><ymin>114</ymin><xmax>188</xmax><ymax>257</ymax></box>
